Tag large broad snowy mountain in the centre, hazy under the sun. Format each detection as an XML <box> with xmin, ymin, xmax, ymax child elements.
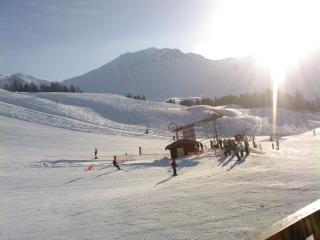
<box><xmin>63</xmin><ymin>48</ymin><xmax>320</xmax><ymax>100</ymax></box>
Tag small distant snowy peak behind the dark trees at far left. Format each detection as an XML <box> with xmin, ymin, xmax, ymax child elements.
<box><xmin>0</xmin><ymin>73</ymin><xmax>50</xmax><ymax>88</ymax></box>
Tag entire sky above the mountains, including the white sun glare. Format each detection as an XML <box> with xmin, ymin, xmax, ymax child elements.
<box><xmin>0</xmin><ymin>0</ymin><xmax>320</xmax><ymax>81</ymax></box>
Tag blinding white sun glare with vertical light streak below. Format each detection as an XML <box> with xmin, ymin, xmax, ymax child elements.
<box><xmin>193</xmin><ymin>0</ymin><xmax>320</xmax><ymax>132</ymax></box>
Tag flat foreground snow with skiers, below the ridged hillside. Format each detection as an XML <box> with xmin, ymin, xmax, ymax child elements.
<box><xmin>0</xmin><ymin>116</ymin><xmax>320</xmax><ymax>240</ymax></box>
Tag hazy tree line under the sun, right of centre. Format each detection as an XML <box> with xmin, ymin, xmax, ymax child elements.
<box><xmin>172</xmin><ymin>89</ymin><xmax>320</xmax><ymax>111</ymax></box>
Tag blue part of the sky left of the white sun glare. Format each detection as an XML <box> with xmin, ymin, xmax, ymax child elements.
<box><xmin>0</xmin><ymin>0</ymin><xmax>217</xmax><ymax>81</ymax></box>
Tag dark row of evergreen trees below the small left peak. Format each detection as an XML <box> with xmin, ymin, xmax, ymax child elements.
<box><xmin>3</xmin><ymin>80</ymin><xmax>82</xmax><ymax>92</ymax></box>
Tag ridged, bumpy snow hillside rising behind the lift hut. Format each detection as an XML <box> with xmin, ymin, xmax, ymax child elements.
<box><xmin>0</xmin><ymin>90</ymin><xmax>320</xmax><ymax>137</ymax></box>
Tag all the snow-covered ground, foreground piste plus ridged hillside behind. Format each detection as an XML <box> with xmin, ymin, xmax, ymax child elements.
<box><xmin>0</xmin><ymin>91</ymin><xmax>320</xmax><ymax>240</ymax></box>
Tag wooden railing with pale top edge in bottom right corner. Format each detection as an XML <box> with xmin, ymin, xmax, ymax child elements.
<box><xmin>248</xmin><ymin>199</ymin><xmax>320</xmax><ymax>240</ymax></box>
